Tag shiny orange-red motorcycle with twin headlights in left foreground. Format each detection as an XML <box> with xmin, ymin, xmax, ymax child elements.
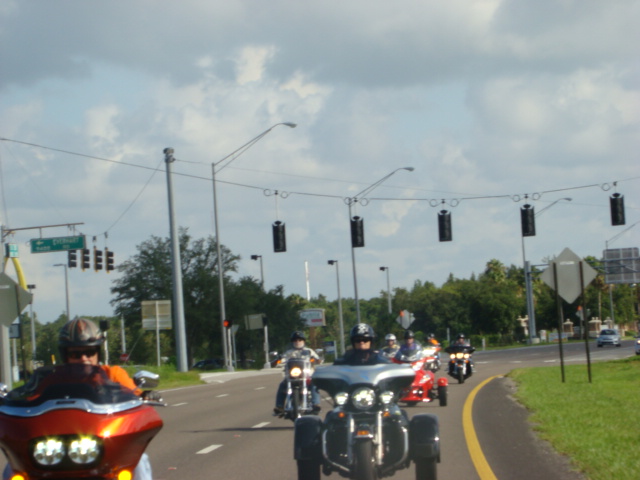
<box><xmin>0</xmin><ymin>364</ymin><xmax>164</xmax><ymax>480</ymax></box>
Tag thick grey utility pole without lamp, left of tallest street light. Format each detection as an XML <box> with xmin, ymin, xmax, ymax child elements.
<box><xmin>163</xmin><ymin>148</ymin><xmax>188</xmax><ymax>372</ymax></box>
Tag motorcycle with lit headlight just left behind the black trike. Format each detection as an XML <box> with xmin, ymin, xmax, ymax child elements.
<box><xmin>281</xmin><ymin>356</ymin><xmax>314</xmax><ymax>422</ymax></box>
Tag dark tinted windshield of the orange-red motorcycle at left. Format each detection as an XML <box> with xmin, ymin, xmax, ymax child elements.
<box><xmin>3</xmin><ymin>364</ymin><xmax>138</xmax><ymax>407</ymax></box>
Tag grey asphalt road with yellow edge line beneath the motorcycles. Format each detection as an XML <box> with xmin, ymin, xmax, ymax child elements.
<box><xmin>1</xmin><ymin>341</ymin><xmax>634</xmax><ymax>480</ymax></box>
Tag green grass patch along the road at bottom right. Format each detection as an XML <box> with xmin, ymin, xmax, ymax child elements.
<box><xmin>509</xmin><ymin>357</ymin><xmax>640</xmax><ymax>480</ymax></box>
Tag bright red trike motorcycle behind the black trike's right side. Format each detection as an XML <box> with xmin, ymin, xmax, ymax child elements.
<box><xmin>392</xmin><ymin>348</ymin><xmax>449</xmax><ymax>407</ymax></box>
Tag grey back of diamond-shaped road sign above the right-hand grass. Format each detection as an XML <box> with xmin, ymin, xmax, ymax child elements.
<box><xmin>540</xmin><ymin>248</ymin><xmax>598</xmax><ymax>303</ymax></box>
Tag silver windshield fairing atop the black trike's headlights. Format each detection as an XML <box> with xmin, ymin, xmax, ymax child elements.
<box><xmin>312</xmin><ymin>364</ymin><xmax>415</xmax><ymax>396</ymax></box>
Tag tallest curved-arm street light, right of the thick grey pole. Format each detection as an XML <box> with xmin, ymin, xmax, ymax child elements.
<box><xmin>211</xmin><ymin>122</ymin><xmax>296</xmax><ymax>372</ymax></box>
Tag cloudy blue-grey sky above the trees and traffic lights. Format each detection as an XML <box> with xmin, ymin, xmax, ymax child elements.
<box><xmin>0</xmin><ymin>0</ymin><xmax>640</xmax><ymax>322</ymax></box>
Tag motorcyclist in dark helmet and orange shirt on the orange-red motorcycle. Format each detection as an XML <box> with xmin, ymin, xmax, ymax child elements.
<box><xmin>3</xmin><ymin>318</ymin><xmax>162</xmax><ymax>480</ymax></box>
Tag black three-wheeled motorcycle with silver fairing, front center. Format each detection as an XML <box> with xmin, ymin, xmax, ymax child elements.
<box><xmin>294</xmin><ymin>364</ymin><xmax>440</xmax><ymax>480</ymax></box>
